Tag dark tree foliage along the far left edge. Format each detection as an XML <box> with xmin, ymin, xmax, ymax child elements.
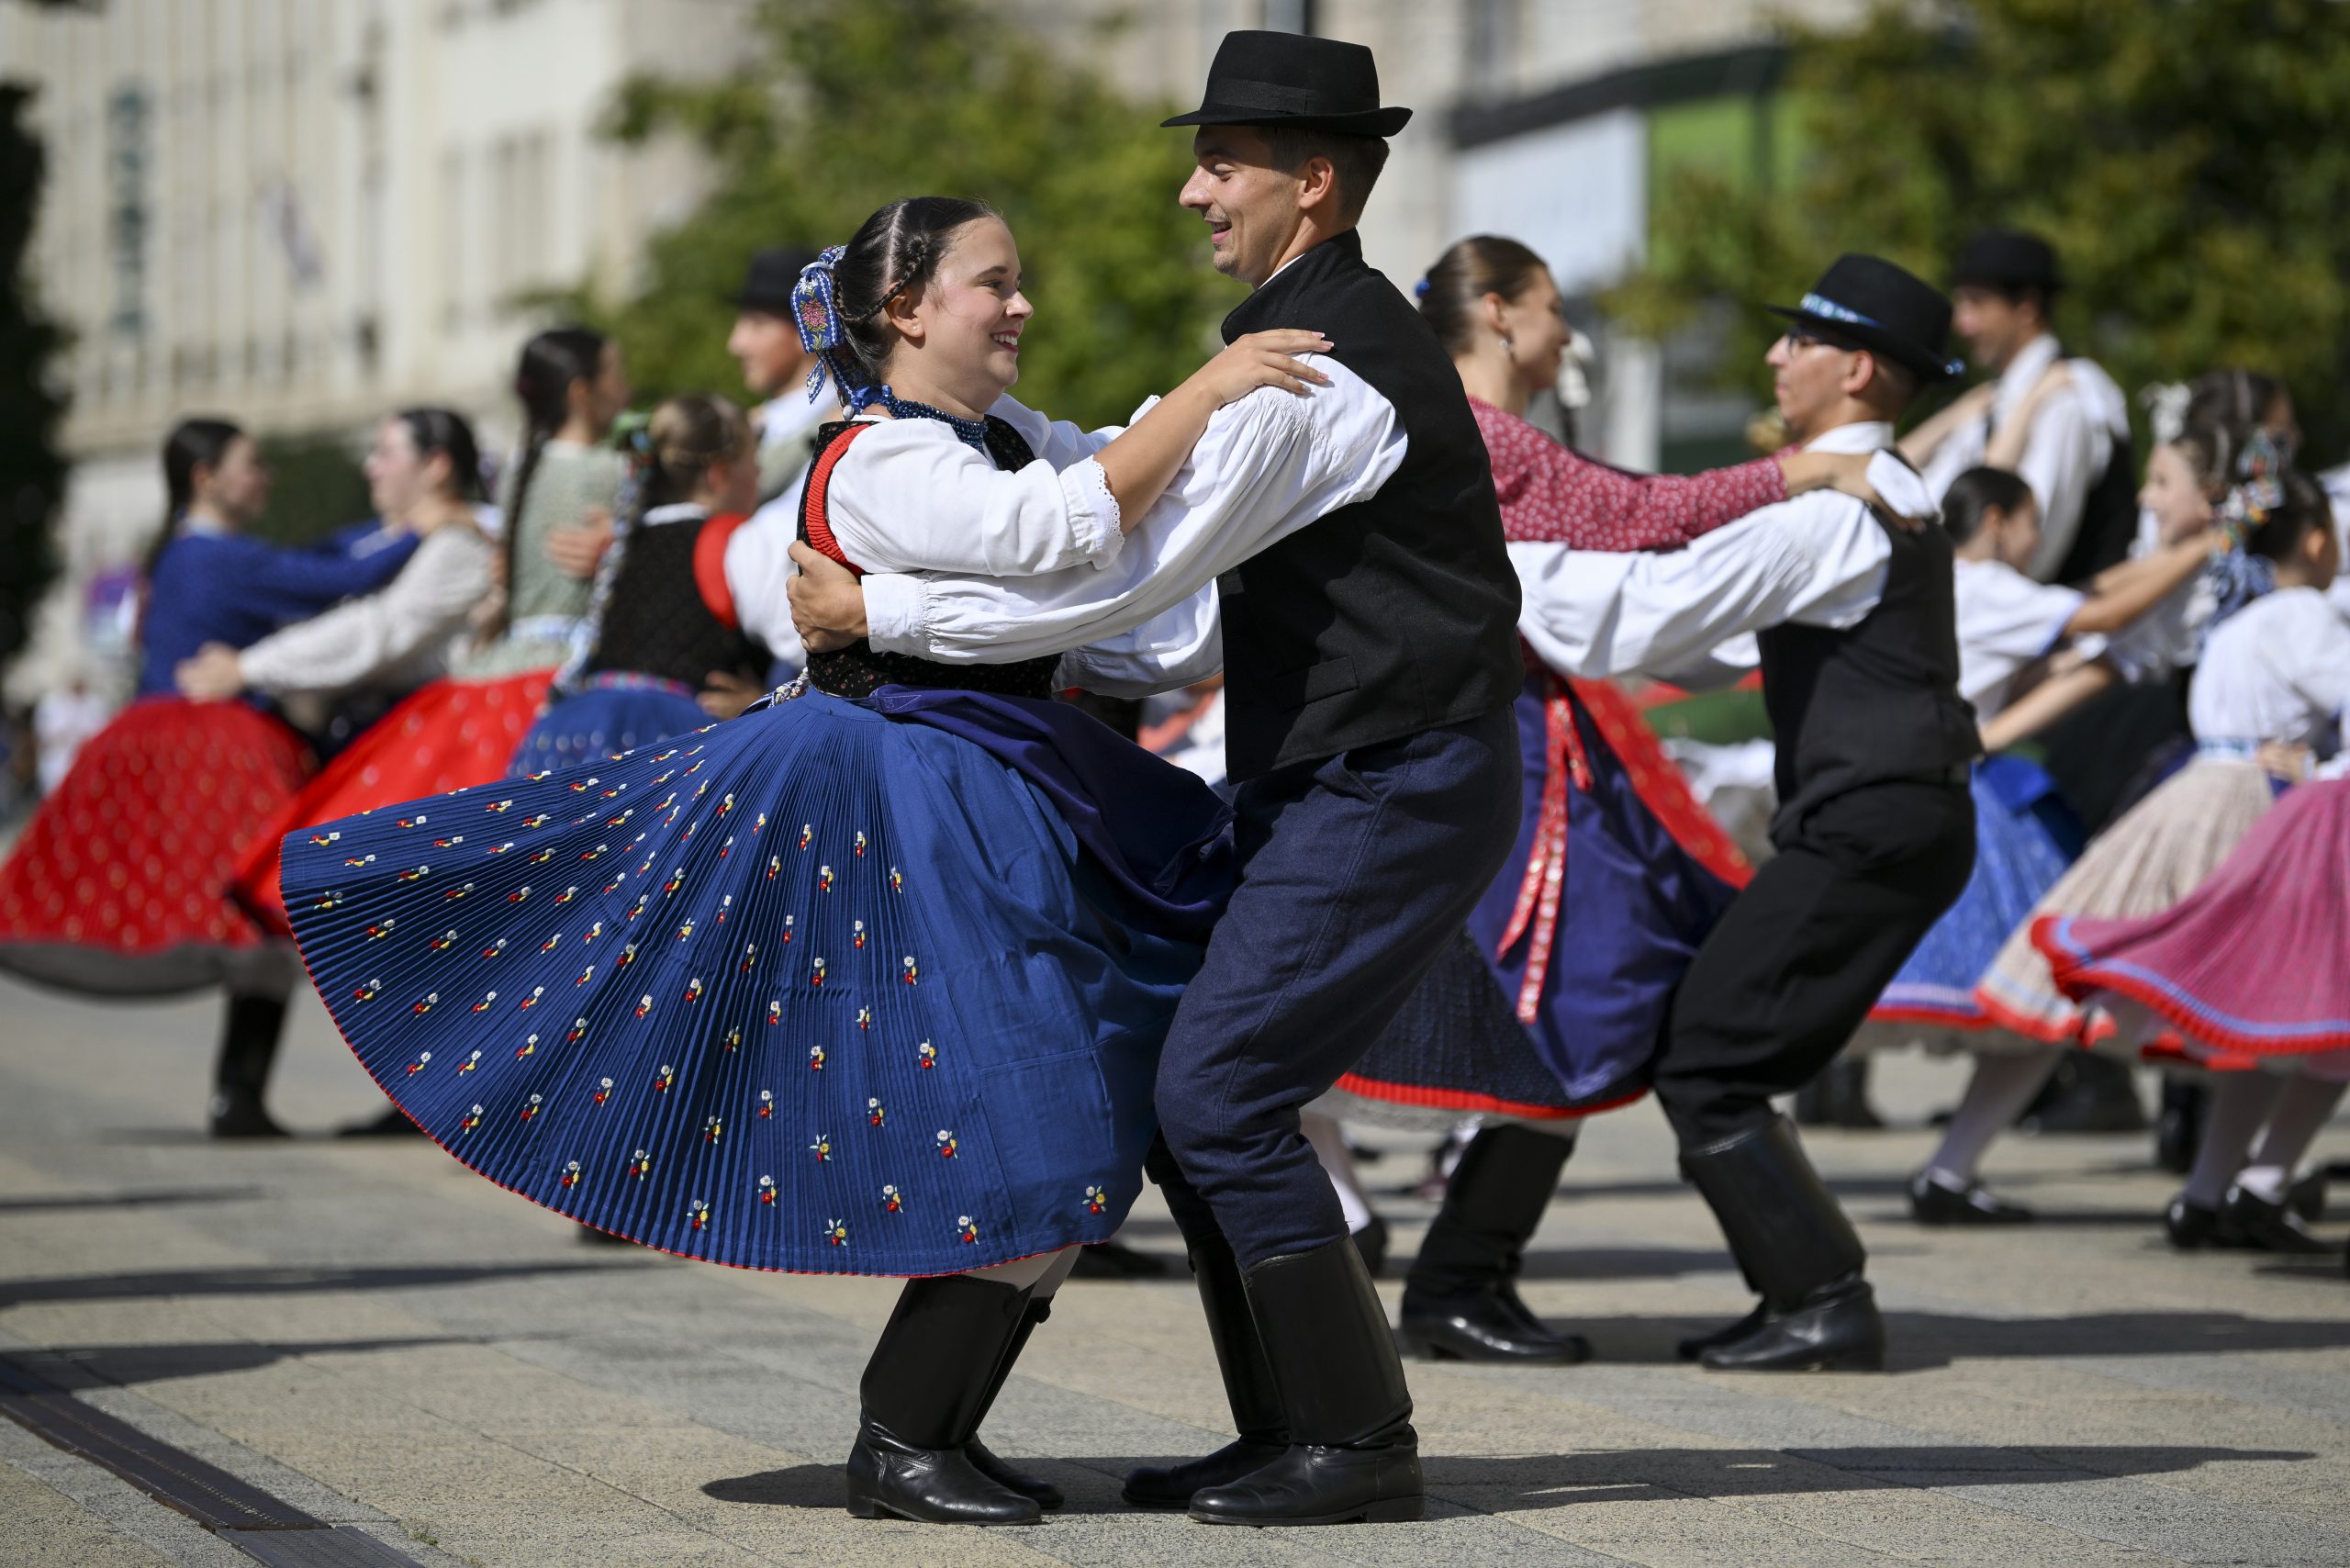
<box><xmin>0</xmin><ymin>83</ymin><xmax>66</xmax><ymax>666</ymax></box>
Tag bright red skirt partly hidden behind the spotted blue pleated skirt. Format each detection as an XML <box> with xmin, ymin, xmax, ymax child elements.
<box><xmin>232</xmin><ymin>670</ymin><xmax>554</xmax><ymax>935</ymax></box>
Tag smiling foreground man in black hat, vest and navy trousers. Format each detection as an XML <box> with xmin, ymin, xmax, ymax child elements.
<box><xmin>792</xmin><ymin>33</ymin><xmax>1523</xmax><ymax>1526</ymax></box>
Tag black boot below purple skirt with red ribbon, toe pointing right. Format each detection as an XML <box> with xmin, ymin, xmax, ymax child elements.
<box><xmin>1401</xmin><ymin>1124</ymin><xmax>1591</xmax><ymax>1366</ymax></box>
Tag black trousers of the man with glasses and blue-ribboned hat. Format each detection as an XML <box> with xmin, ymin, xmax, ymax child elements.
<box><xmin>1654</xmin><ymin>768</ymin><xmax>1974</xmax><ymax>1148</ymax></box>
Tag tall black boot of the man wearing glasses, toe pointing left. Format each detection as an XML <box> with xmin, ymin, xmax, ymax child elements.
<box><xmin>1680</xmin><ymin>1116</ymin><xmax>1885</xmax><ymax>1372</ymax></box>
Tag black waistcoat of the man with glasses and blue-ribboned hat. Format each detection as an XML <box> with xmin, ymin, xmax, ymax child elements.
<box><xmin>1758</xmin><ymin>487</ymin><xmax>1984</xmax><ymax>842</ymax></box>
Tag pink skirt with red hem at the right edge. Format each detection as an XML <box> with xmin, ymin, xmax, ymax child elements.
<box><xmin>2032</xmin><ymin>780</ymin><xmax>2350</xmax><ymax>1068</ymax></box>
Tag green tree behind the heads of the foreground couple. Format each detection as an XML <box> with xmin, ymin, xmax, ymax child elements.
<box><xmin>578</xmin><ymin>0</ymin><xmax>1238</xmax><ymax>423</ymax></box>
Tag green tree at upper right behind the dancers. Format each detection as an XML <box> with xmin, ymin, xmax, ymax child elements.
<box><xmin>1610</xmin><ymin>0</ymin><xmax>2350</xmax><ymax>454</ymax></box>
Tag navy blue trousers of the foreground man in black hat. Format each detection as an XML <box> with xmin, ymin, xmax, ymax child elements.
<box><xmin>1149</xmin><ymin>708</ymin><xmax>1520</xmax><ymax>1270</ymax></box>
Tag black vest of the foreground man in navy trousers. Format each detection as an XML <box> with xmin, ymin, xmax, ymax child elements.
<box><xmin>1217</xmin><ymin>233</ymin><xmax>1525</xmax><ymax>778</ymax></box>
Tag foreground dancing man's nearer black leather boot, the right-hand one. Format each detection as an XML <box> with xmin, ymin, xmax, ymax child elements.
<box><xmin>1192</xmin><ymin>1237</ymin><xmax>1427</xmax><ymax>1526</ymax></box>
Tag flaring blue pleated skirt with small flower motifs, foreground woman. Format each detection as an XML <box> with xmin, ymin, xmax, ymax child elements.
<box><xmin>285</xmin><ymin>689</ymin><xmax>1222</xmax><ymax>1274</ymax></box>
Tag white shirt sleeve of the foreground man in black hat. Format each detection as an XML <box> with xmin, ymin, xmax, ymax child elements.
<box><xmin>865</xmin><ymin>355</ymin><xmax>1407</xmax><ymax>663</ymax></box>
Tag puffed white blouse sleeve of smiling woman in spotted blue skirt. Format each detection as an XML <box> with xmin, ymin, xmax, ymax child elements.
<box><xmin>825</xmin><ymin>419</ymin><xmax>1125</xmax><ymax>578</ymax></box>
